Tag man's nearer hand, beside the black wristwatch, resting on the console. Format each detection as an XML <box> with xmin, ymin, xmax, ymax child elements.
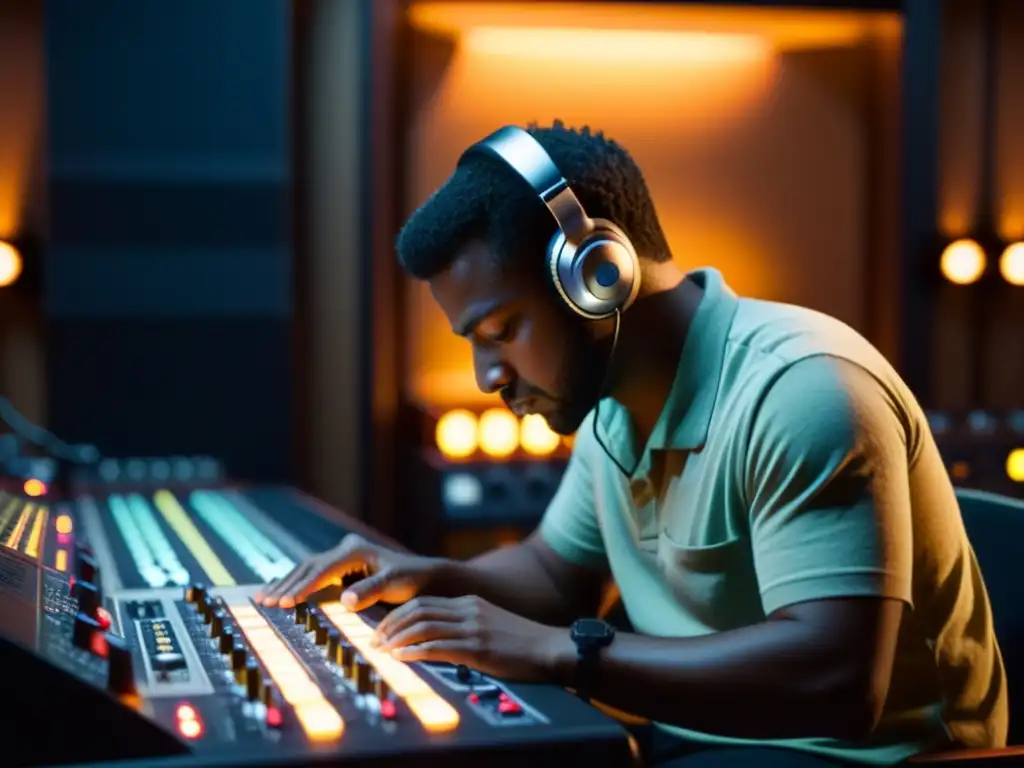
<box><xmin>375</xmin><ymin>596</ymin><xmax>575</xmax><ymax>681</ymax></box>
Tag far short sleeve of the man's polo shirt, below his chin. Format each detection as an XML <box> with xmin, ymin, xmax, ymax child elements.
<box><xmin>540</xmin><ymin>414</ymin><xmax>607</xmax><ymax>568</ymax></box>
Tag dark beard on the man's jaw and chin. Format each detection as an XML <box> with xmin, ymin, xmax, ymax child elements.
<box><xmin>507</xmin><ymin>324</ymin><xmax>612</xmax><ymax>435</ymax></box>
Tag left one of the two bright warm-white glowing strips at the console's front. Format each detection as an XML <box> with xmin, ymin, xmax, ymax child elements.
<box><xmin>227</xmin><ymin>603</ymin><xmax>345</xmax><ymax>742</ymax></box>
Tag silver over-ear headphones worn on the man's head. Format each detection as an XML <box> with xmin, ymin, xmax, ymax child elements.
<box><xmin>459</xmin><ymin>125</ymin><xmax>640</xmax><ymax>319</ymax></box>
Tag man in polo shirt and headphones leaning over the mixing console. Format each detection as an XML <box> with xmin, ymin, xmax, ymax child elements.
<box><xmin>262</xmin><ymin>123</ymin><xmax>1008</xmax><ymax>766</ymax></box>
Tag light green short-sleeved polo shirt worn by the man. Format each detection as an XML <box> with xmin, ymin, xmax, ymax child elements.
<box><xmin>541</xmin><ymin>269</ymin><xmax>1008</xmax><ymax>764</ymax></box>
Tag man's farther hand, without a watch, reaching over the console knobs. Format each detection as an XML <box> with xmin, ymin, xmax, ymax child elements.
<box><xmin>256</xmin><ymin>534</ymin><xmax>445</xmax><ymax>610</ymax></box>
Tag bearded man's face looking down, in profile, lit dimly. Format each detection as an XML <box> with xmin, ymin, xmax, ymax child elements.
<box><xmin>430</xmin><ymin>242</ymin><xmax>609</xmax><ymax>434</ymax></box>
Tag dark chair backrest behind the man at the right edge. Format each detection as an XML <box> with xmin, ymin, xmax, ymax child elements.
<box><xmin>956</xmin><ymin>488</ymin><xmax>1024</xmax><ymax>744</ymax></box>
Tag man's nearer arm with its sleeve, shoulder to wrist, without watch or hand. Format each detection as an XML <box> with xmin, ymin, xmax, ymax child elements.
<box><xmin>549</xmin><ymin>357</ymin><xmax>911</xmax><ymax>739</ymax></box>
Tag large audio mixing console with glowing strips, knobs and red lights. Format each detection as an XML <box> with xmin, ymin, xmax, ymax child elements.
<box><xmin>0</xmin><ymin>483</ymin><xmax>632</xmax><ymax>768</ymax></box>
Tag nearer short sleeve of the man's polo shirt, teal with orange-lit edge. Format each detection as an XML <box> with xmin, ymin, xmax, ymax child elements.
<box><xmin>744</xmin><ymin>356</ymin><xmax>913</xmax><ymax>614</ymax></box>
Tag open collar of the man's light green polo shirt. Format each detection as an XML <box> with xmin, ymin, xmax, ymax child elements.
<box><xmin>598</xmin><ymin>268</ymin><xmax>739</xmax><ymax>476</ymax></box>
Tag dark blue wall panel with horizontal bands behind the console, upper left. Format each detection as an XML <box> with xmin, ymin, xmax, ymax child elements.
<box><xmin>45</xmin><ymin>0</ymin><xmax>294</xmax><ymax>479</ymax></box>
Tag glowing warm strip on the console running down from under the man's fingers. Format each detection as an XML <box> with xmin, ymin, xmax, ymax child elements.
<box><xmin>319</xmin><ymin>602</ymin><xmax>459</xmax><ymax>733</ymax></box>
